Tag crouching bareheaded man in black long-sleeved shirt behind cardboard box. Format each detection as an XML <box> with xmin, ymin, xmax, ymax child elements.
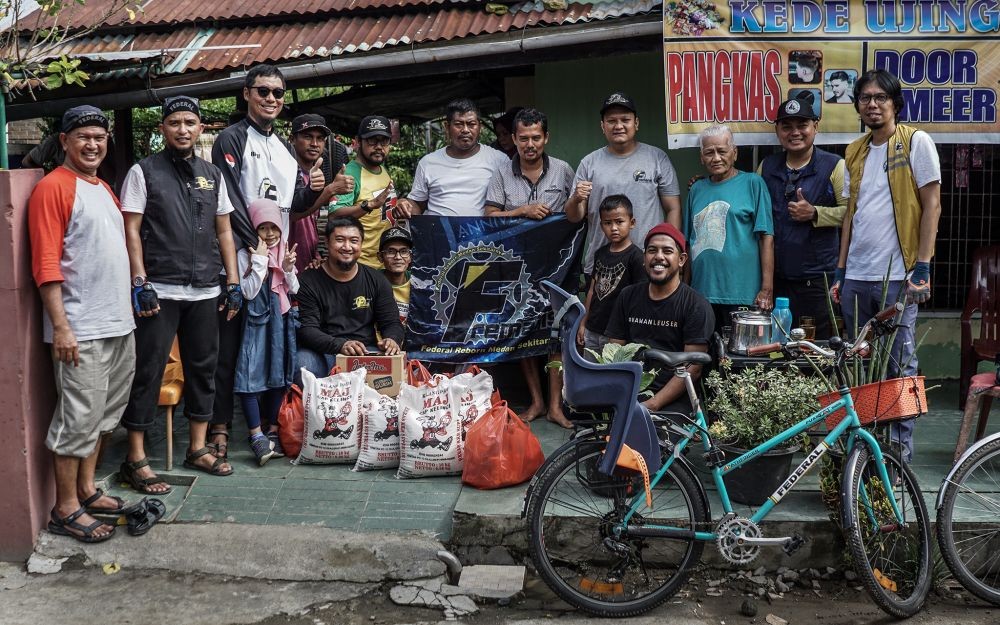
<box><xmin>297</xmin><ymin>217</ymin><xmax>403</xmax><ymax>376</ymax></box>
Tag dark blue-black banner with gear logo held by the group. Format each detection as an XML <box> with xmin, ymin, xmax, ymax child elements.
<box><xmin>406</xmin><ymin>215</ymin><xmax>584</xmax><ymax>363</ymax></box>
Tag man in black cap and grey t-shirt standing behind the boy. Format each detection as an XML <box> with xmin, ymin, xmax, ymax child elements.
<box><xmin>566</xmin><ymin>92</ymin><xmax>681</xmax><ymax>276</ymax></box>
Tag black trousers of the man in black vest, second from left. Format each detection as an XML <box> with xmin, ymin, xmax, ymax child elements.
<box><xmin>122</xmin><ymin>297</ymin><xmax>219</xmax><ymax>431</ymax></box>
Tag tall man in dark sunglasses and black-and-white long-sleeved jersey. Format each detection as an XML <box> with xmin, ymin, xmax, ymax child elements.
<box><xmin>209</xmin><ymin>64</ymin><xmax>326</xmax><ymax>458</ymax></box>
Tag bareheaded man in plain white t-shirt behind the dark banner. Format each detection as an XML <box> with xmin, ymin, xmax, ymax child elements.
<box><xmin>393</xmin><ymin>98</ymin><xmax>510</xmax><ymax>219</ymax></box>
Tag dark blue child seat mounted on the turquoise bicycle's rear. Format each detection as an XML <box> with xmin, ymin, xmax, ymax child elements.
<box><xmin>542</xmin><ymin>280</ymin><xmax>661</xmax><ymax>475</ymax></box>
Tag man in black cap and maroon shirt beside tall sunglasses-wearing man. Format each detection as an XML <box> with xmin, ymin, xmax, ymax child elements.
<box><xmin>288</xmin><ymin>113</ymin><xmax>354</xmax><ymax>272</ymax></box>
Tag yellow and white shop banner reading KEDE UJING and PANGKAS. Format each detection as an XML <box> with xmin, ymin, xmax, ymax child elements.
<box><xmin>663</xmin><ymin>0</ymin><xmax>1000</xmax><ymax>148</ymax></box>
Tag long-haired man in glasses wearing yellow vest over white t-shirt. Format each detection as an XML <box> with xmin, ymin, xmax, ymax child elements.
<box><xmin>830</xmin><ymin>70</ymin><xmax>941</xmax><ymax>461</ymax></box>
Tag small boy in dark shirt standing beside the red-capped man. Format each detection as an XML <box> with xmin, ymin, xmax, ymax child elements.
<box><xmin>576</xmin><ymin>195</ymin><xmax>646</xmax><ymax>361</ymax></box>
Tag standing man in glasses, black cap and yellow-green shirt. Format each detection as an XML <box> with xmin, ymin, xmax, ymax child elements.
<box><xmin>333</xmin><ymin>115</ymin><xmax>396</xmax><ymax>269</ymax></box>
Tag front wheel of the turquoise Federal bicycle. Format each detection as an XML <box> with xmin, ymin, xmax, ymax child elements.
<box><xmin>841</xmin><ymin>443</ymin><xmax>931</xmax><ymax>618</ymax></box>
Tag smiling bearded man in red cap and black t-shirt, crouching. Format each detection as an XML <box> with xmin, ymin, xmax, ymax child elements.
<box><xmin>606</xmin><ymin>223</ymin><xmax>715</xmax><ymax>414</ymax></box>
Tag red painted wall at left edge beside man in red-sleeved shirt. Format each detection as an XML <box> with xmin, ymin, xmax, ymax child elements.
<box><xmin>0</xmin><ymin>169</ymin><xmax>55</xmax><ymax>561</ymax></box>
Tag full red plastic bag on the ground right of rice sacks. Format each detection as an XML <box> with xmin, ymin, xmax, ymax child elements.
<box><xmin>462</xmin><ymin>402</ymin><xmax>545</xmax><ymax>490</ymax></box>
